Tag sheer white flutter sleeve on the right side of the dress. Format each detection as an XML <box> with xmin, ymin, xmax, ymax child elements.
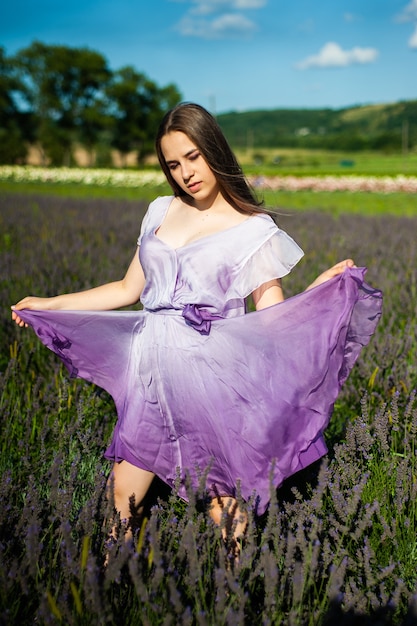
<box><xmin>228</xmin><ymin>229</ymin><xmax>304</xmax><ymax>298</ymax></box>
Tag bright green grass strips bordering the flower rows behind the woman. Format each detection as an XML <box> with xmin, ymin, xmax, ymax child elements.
<box><xmin>0</xmin><ymin>149</ymin><xmax>417</xmax><ymax>216</ymax></box>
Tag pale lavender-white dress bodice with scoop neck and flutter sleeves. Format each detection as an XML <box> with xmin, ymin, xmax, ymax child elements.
<box><xmin>138</xmin><ymin>196</ymin><xmax>303</xmax><ymax>317</ymax></box>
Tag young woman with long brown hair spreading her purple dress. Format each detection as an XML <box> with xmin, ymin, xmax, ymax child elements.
<box><xmin>12</xmin><ymin>103</ymin><xmax>381</xmax><ymax>552</ymax></box>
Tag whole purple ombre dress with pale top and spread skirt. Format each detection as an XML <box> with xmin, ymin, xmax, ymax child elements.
<box><xmin>19</xmin><ymin>197</ymin><xmax>382</xmax><ymax>513</ymax></box>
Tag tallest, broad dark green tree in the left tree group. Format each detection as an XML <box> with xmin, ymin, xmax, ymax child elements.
<box><xmin>14</xmin><ymin>42</ymin><xmax>111</xmax><ymax>165</ymax></box>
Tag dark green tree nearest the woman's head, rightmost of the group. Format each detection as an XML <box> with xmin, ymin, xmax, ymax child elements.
<box><xmin>106</xmin><ymin>66</ymin><xmax>181</xmax><ymax>161</ymax></box>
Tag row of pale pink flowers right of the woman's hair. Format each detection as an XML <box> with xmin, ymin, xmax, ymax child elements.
<box><xmin>249</xmin><ymin>176</ymin><xmax>417</xmax><ymax>193</ymax></box>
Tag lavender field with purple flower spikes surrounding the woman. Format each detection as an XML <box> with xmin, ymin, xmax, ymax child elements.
<box><xmin>0</xmin><ymin>193</ymin><xmax>417</xmax><ymax>626</ymax></box>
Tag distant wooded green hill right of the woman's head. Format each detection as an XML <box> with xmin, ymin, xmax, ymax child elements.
<box><xmin>217</xmin><ymin>100</ymin><xmax>417</xmax><ymax>152</ymax></box>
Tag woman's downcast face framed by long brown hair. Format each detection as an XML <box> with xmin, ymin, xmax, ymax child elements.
<box><xmin>161</xmin><ymin>131</ymin><xmax>220</xmax><ymax>207</ymax></box>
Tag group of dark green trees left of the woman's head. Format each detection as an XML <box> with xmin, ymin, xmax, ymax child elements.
<box><xmin>0</xmin><ymin>41</ymin><xmax>181</xmax><ymax>166</ymax></box>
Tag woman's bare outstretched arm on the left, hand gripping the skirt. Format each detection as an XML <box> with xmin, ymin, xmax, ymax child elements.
<box><xmin>12</xmin><ymin>250</ymin><xmax>145</xmax><ymax>326</ymax></box>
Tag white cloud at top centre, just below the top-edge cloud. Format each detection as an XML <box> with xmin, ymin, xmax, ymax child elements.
<box><xmin>177</xmin><ymin>13</ymin><xmax>256</xmax><ymax>39</ymax></box>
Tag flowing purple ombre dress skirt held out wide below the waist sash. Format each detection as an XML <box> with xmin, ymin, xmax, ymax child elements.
<box><xmin>19</xmin><ymin>268</ymin><xmax>382</xmax><ymax>513</ymax></box>
